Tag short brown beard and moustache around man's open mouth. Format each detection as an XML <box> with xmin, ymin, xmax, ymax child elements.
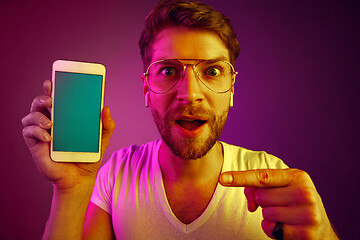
<box><xmin>152</xmin><ymin>102</ymin><xmax>229</xmax><ymax>160</ymax></box>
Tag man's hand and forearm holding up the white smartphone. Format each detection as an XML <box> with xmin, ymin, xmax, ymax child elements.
<box><xmin>22</xmin><ymin>81</ymin><xmax>115</xmax><ymax>239</ymax></box>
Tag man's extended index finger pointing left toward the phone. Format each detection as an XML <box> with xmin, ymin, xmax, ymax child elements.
<box><xmin>220</xmin><ymin>169</ymin><xmax>300</xmax><ymax>187</ymax></box>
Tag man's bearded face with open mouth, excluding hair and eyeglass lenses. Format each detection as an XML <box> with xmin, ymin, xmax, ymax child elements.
<box><xmin>143</xmin><ymin>27</ymin><xmax>233</xmax><ymax>159</ymax></box>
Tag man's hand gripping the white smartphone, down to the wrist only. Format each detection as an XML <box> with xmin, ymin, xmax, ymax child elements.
<box><xmin>22</xmin><ymin>80</ymin><xmax>115</xmax><ymax>191</ymax></box>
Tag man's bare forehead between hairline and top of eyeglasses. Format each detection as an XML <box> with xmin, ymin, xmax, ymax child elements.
<box><xmin>152</xmin><ymin>27</ymin><xmax>230</xmax><ymax>61</ymax></box>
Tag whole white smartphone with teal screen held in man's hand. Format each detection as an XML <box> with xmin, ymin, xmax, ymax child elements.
<box><xmin>50</xmin><ymin>60</ymin><xmax>105</xmax><ymax>162</ymax></box>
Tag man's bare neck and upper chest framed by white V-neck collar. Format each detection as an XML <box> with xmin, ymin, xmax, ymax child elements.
<box><xmin>159</xmin><ymin>142</ymin><xmax>224</xmax><ymax>224</ymax></box>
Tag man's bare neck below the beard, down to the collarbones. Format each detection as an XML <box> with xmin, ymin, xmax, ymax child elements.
<box><xmin>159</xmin><ymin>142</ymin><xmax>224</xmax><ymax>184</ymax></box>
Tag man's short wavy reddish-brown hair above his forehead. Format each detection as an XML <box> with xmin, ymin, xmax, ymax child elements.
<box><xmin>139</xmin><ymin>0</ymin><xmax>240</xmax><ymax>68</ymax></box>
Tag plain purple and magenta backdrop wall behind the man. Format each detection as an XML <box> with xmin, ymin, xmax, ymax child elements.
<box><xmin>0</xmin><ymin>0</ymin><xmax>360</xmax><ymax>239</ymax></box>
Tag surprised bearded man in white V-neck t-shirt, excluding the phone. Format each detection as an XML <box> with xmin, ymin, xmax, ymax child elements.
<box><xmin>23</xmin><ymin>1</ymin><xmax>337</xmax><ymax>239</ymax></box>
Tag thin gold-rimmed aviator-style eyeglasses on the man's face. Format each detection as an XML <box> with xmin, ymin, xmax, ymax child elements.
<box><xmin>143</xmin><ymin>59</ymin><xmax>237</xmax><ymax>94</ymax></box>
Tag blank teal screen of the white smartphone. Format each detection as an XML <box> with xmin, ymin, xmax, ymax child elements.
<box><xmin>53</xmin><ymin>71</ymin><xmax>103</xmax><ymax>152</ymax></box>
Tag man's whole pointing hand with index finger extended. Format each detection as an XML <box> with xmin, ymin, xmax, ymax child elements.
<box><xmin>219</xmin><ymin>169</ymin><xmax>338</xmax><ymax>239</ymax></box>
